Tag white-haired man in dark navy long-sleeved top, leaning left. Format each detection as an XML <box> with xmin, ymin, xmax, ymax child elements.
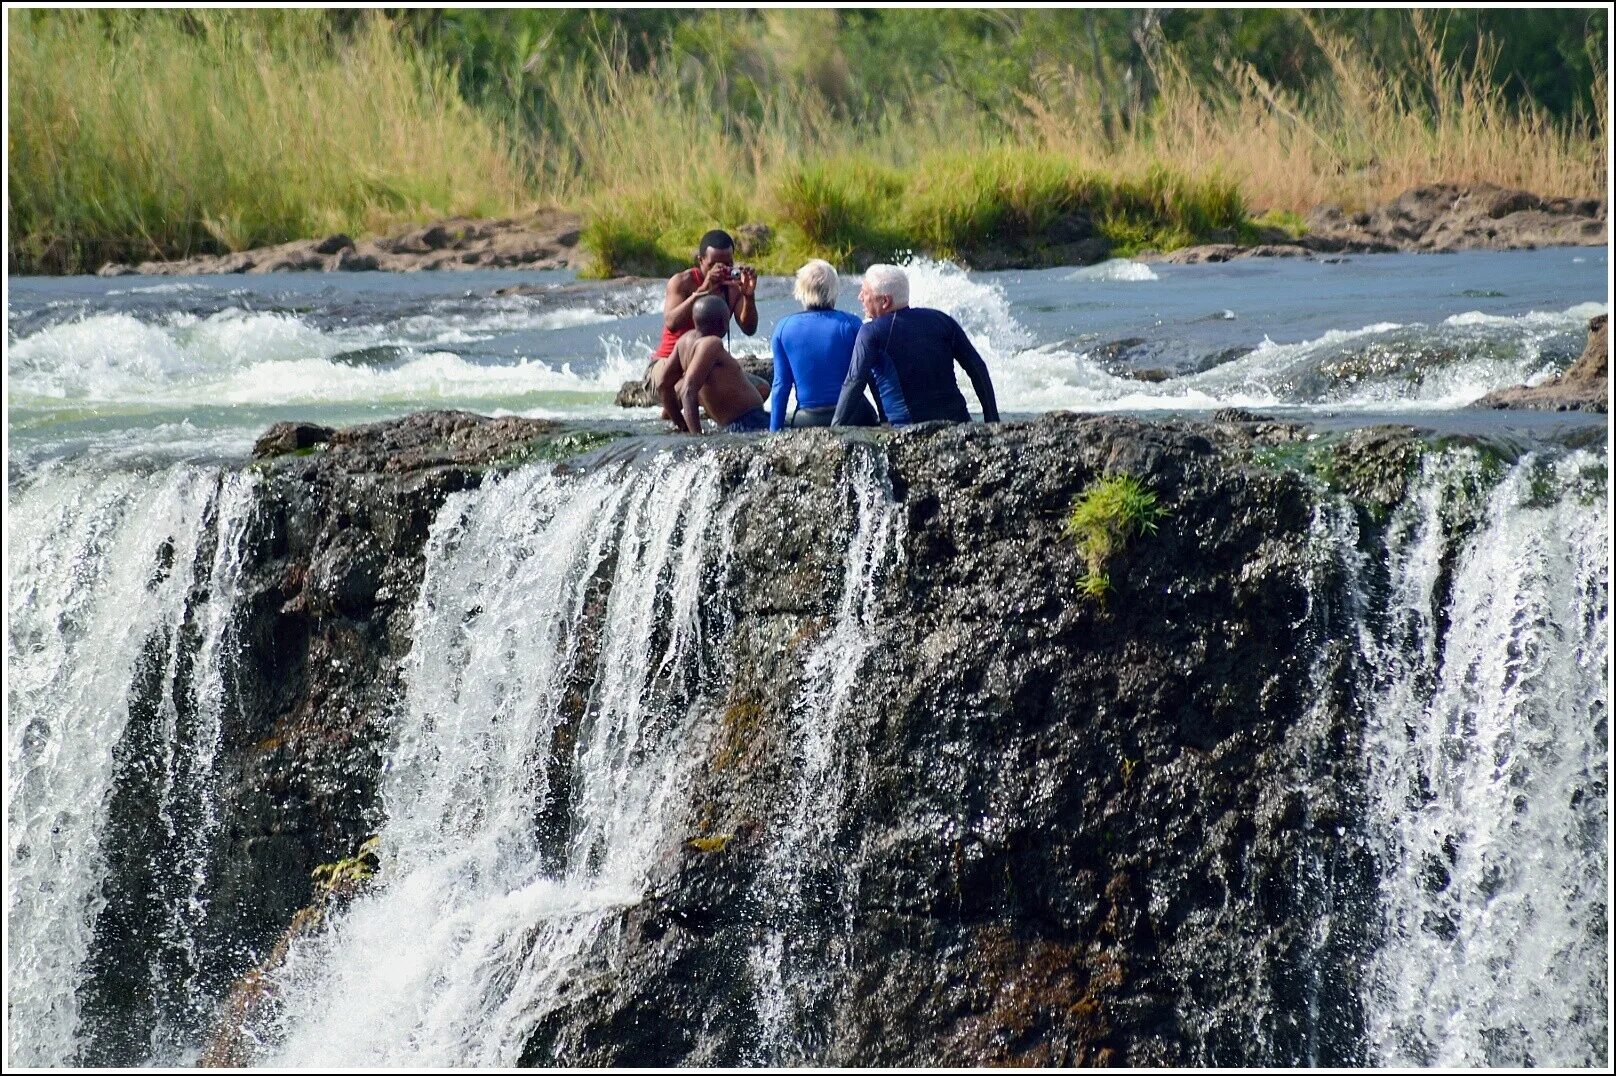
<box><xmin>831</xmin><ymin>265</ymin><xmax>999</xmax><ymax>427</ymax></box>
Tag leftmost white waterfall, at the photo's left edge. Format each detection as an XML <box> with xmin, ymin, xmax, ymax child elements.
<box><xmin>6</xmin><ymin>467</ymin><xmax>252</xmax><ymax>1065</ymax></box>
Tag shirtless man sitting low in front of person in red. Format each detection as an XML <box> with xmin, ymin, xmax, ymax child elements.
<box><xmin>661</xmin><ymin>296</ymin><xmax>769</xmax><ymax>435</ymax></box>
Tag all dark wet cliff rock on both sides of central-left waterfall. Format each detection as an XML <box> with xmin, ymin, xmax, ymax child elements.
<box><xmin>151</xmin><ymin>412</ymin><xmax>1401</xmax><ymax>1066</ymax></box>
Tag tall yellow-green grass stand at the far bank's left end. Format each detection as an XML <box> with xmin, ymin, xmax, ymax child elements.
<box><xmin>6</xmin><ymin>10</ymin><xmax>532</xmax><ymax>270</ymax></box>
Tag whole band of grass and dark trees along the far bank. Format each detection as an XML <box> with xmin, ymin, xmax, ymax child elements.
<box><xmin>6</xmin><ymin>10</ymin><xmax>1608</xmax><ymax>276</ymax></box>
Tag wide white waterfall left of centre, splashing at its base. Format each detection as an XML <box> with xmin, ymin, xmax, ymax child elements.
<box><xmin>265</xmin><ymin>456</ymin><xmax>742</xmax><ymax>1066</ymax></box>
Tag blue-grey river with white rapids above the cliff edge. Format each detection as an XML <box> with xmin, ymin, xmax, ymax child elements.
<box><xmin>6</xmin><ymin>247</ymin><xmax>1608</xmax><ymax>469</ymax></box>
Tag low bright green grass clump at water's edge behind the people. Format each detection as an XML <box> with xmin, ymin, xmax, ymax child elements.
<box><xmin>583</xmin><ymin>147</ymin><xmax>1246</xmax><ymax>276</ymax></box>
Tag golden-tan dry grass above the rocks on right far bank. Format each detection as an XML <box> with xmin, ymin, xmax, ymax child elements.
<box><xmin>1012</xmin><ymin>11</ymin><xmax>1608</xmax><ymax>212</ymax></box>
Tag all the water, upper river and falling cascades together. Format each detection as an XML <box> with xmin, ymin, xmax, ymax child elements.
<box><xmin>6</xmin><ymin>249</ymin><xmax>1610</xmax><ymax>1066</ymax></box>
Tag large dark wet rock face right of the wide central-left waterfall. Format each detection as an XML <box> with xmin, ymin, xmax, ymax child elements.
<box><xmin>525</xmin><ymin>415</ymin><xmax>1367</xmax><ymax>1065</ymax></box>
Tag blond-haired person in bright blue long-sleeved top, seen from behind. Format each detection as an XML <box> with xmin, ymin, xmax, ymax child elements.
<box><xmin>769</xmin><ymin>258</ymin><xmax>876</xmax><ymax>430</ymax></box>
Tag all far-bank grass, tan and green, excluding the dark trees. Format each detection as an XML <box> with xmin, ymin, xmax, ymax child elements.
<box><xmin>8</xmin><ymin>11</ymin><xmax>1608</xmax><ymax>273</ymax></box>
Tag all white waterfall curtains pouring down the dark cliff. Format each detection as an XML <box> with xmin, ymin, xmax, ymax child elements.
<box><xmin>6</xmin><ymin>429</ymin><xmax>1610</xmax><ymax>1066</ymax></box>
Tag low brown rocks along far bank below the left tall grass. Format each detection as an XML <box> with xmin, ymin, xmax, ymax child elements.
<box><xmin>99</xmin><ymin>212</ymin><xmax>579</xmax><ymax>276</ymax></box>
